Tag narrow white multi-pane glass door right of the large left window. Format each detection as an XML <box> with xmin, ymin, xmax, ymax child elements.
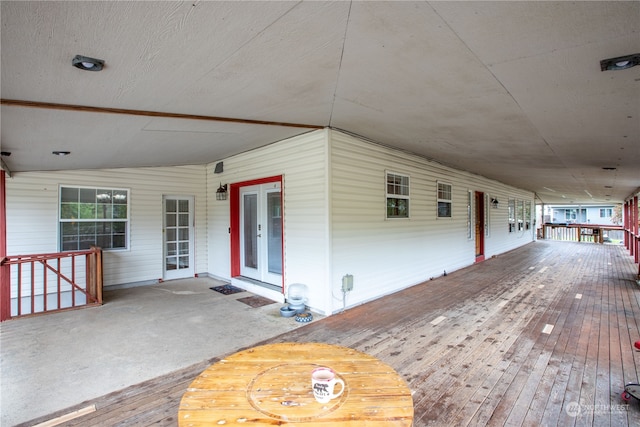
<box><xmin>163</xmin><ymin>196</ymin><xmax>195</xmax><ymax>280</ymax></box>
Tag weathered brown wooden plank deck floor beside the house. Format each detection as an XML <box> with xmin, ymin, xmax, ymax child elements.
<box><xmin>20</xmin><ymin>241</ymin><xmax>640</xmax><ymax>427</ymax></box>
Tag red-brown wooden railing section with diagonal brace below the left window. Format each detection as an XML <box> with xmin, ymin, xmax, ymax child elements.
<box><xmin>0</xmin><ymin>247</ymin><xmax>102</xmax><ymax>321</ymax></box>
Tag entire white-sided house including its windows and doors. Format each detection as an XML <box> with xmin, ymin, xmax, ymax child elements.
<box><xmin>6</xmin><ymin>129</ymin><xmax>535</xmax><ymax>315</ymax></box>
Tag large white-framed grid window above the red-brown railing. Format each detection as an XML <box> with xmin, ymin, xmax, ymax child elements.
<box><xmin>59</xmin><ymin>186</ymin><xmax>129</xmax><ymax>251</ymax></box>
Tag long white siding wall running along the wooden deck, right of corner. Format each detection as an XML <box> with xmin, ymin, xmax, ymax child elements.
<box><xmin>329</xmin><ymin>131</ymin><xmax>535</xmax><ymax>311</ymax></box>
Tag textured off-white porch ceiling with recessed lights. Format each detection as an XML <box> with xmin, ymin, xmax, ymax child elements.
<box><xmin>0</xmin><ymin>1</ymin><xmax>640</xmax><ymax>203</ymax></box>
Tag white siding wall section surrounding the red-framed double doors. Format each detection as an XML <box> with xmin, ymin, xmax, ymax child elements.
<box><xmin>207</xmin><ymin>130</ymin><xmax>329</xmax><ymax>312</ymax></box>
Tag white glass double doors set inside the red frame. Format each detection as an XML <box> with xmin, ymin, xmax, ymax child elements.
<box><xmin>240</xmin><ymin>182</ymin><xmax>282</xmax><ymax>286</ymax></box>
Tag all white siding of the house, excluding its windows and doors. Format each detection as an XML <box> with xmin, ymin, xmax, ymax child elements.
<box><xmin>7</xmin><ymin>130</ymin><xmax>535</xmax><ymax>314</ymax></box>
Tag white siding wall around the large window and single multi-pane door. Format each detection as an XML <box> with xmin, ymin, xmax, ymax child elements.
<box><xmin>6</xmin><ymin>166</ymin><xmax>208</xmax><ymax>286</ymax></box>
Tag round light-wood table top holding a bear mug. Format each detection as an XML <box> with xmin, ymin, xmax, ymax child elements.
<box><xmin>178</xmin><ymin>343</ymin><xmax>413</xmax><ymax>427</ymax></box>
